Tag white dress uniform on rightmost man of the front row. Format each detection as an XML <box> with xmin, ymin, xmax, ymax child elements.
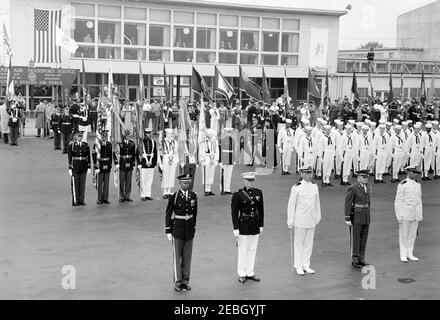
<box><xmin>394</xmin><ymin>178</ymin><xmax>423</xmax><ymax>261</ymax></box>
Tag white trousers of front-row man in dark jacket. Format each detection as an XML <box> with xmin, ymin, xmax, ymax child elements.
<box><xmin>237</xmin><ymin>234</ymin><xmax>260</xmax><ymax>277</ymax></box>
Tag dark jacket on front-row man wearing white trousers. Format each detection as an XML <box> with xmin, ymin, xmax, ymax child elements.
<box><xmin>231</xmin><ymin>188</ymin><xmax>264</xmax><ymax>235</ymax></box>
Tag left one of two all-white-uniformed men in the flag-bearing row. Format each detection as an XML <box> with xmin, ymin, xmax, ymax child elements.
<box><xmin>159</xmin><ymin>128</ymin><xmax>179</xmax><ymax>199</ymax></box>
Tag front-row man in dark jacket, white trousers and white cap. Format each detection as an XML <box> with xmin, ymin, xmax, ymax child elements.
<box><xmin>231</xmin><ymin>172</ymin><xmax>264</xmax><ymax>284</ymax></box>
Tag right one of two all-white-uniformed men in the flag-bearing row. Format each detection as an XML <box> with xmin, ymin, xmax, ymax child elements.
<box><xmin>199</xmin><ymin>129</ymin><xmax>220</xmax><ymax>196</ymax></box>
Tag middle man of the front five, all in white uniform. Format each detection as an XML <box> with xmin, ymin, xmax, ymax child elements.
<box><xmin>287</xmin><ymin>166</ymin><xmax>321</xmax><ymax>275</ymax></box>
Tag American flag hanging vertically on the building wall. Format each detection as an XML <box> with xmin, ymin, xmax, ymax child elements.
<box><xmin>34</xmin><ymin>9</ymin><xmax>61</xmax><ymax>63</ymax></box>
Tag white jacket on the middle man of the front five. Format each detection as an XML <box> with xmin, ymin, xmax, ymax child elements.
<box><xmin>287</xmin><ymin>181</ymin><xmax>321</xmax><ymax>229</ymax></box>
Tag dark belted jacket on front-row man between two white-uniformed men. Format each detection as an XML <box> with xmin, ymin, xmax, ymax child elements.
<box><xmin>345</xmin><ymin>182</ymin><xmax>371</xmax><ymax>225</ymax></box>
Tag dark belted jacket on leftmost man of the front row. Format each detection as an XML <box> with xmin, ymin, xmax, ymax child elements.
<box><xmin>165</xmin><ymin>190</ymin><xmax>197</xmax><ymax>241</ymax></box>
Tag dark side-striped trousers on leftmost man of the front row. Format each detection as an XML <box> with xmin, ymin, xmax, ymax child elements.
<box><xmin>173</xmin><ymin>238</ymin><xmax>193</xmax><ymax>284</ymax></box>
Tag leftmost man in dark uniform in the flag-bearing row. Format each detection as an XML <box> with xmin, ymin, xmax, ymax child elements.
<box><xmin>68</xmin><ymin>131</ymin><xmax>91</xmax><ymax>207</ymax></box>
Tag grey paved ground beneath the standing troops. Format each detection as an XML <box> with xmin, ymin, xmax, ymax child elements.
<box><xmin>0</xmin><ymin>132</ymin><xmax>440</xmax><ymax>300</ymax></box>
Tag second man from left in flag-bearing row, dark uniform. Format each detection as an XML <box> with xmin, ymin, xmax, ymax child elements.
<box><xmin>92</xmin><ymin>130</ymin><xmax>113</xmax><ymax>204</ymax></box>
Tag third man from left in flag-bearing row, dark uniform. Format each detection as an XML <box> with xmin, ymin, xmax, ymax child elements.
<box><xmin>114</xmin><ymin>130</ymin><xmax>136</xmax><ymax>202</ymax></box>
